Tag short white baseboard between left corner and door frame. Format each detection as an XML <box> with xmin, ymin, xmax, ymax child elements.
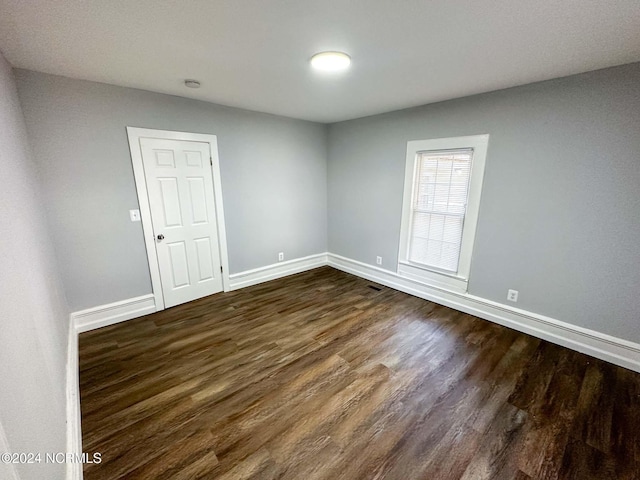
<box><xmin>71</xmin><ymin>293</ymin><xmax>156</xmax><ymax>333</ymax></box>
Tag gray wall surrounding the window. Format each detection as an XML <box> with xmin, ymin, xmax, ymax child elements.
<box><xmin>328</xmin><ymin>64</ymin><xmax>640</xmax><ymax>342</ymax></box>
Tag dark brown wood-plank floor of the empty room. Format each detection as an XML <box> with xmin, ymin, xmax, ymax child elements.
<box><xmin>80</xmin><ymin>267</ymin><xmax>640</xmax><ymax>480</ymax></box>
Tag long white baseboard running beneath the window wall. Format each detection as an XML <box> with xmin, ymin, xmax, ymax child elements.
<box><xmin>328</xmin><ymin>253</ymin><xmax>640</xmax><ymax>372</ymax></box>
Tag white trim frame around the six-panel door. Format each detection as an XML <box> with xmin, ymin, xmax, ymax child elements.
<box><xmin>127</xmin><ymin>127</ymin><xmax>231</xmax><ymax>311</ymax></box>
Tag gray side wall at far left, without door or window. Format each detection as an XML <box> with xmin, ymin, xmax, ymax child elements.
<box><xmin>0</xmin><ymin>54</ymin><xmax>69</xmax><ymax>480</ymax></box>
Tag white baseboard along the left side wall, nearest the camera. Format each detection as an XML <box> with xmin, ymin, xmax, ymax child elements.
<box><xmin>67</xmin><ymin>323</ymin><xmax>83</xmax><ymax>480</ymax></box>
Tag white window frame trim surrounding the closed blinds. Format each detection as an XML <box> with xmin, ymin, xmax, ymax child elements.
<box><xmin>397</xmin><ymin>134</ymin><xmax>489</xmax><ymax>293</ymax></box>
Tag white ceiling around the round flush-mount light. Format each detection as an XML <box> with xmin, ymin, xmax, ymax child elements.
<box><xmin>0</xmin><ymin>0</ymin><xmax>640</xmax><ymax>122</ymax></box>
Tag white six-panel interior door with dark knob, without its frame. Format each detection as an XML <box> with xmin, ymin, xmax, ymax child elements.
<box><xmin>140</xmin><ymin>138</ymin><xmax>222</xmax><ymax>307</ymax></box>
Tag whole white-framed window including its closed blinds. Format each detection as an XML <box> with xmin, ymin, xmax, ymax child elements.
<box><xmin>398</xmin><ymin>135</ymin><xmax>489</xmax><ymax>292</ymax></box>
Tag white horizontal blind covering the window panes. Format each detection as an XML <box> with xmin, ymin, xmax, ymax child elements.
<box><xmin>408</xmin><ymin>148</ymin><xmax>473</xmax><ymax>273</ymax></box>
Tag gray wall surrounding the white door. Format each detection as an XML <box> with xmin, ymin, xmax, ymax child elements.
<box><xmin>16</xmin><ymin>70</ymin><xmax>327</xmax><ymax>311</ymax></box>
